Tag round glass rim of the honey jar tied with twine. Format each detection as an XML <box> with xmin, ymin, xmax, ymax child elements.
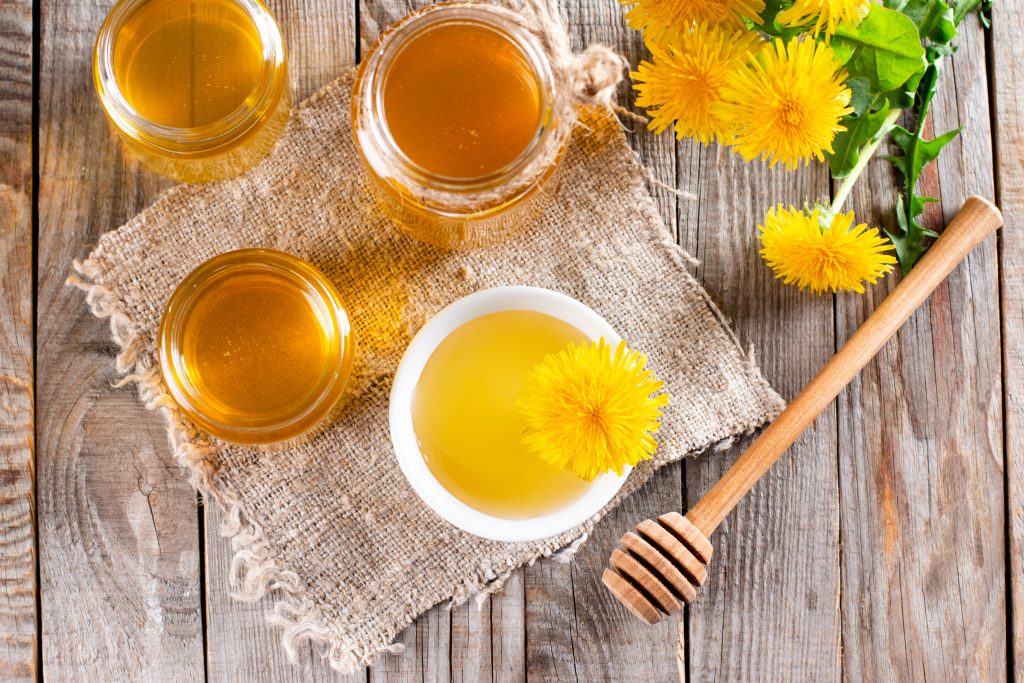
<box><xmin>352</xmin><ymin>2</ymin><xmax>556</xmax><ymax>195</ymax></box>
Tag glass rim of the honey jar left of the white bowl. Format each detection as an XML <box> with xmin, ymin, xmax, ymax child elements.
<box><xmin>158</xmin><ymin>249</ymin><xmax>354</xmax><ymax>443</ymax></box>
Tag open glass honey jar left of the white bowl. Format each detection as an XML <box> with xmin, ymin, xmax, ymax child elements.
<box><xmin>158</xmin><ymin>249</ymin><xmax>353</xmax><ymax>443</ymax></box>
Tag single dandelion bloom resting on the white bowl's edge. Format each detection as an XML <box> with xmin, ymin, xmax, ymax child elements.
<box><xmin>517</xmin><ymin>339</ymin><xmax>669</xmax><ymax>480</ymax></box>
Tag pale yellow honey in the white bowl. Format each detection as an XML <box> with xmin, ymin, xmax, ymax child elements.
<box><xmin>413</xmin><ymin>310</ymin><xmax>591</xmax><ymax>519</ymax></box>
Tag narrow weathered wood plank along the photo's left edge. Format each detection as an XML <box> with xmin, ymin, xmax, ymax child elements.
<box><xmin>0</xmin><ymin>0</ymin><xmax>38</xmax><ymax>681</ymax></box>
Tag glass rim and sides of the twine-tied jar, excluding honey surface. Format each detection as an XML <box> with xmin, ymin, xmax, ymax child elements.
<box><xmin>351</xmin><ymin>3</ymin><xmax>565</xmax><ymax>249</ymax></box>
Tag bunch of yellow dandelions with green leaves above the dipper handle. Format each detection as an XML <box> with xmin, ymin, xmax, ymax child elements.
<box><xmin>620</xmin><ymin>0</ymin><xmax>990</xmax><ymax>293</ymax></box>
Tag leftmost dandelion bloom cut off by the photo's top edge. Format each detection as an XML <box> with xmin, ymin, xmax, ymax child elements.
<box><xmin>618</xmin><ymin>0</ymin><xmax>765</xmax><ymax>43</ymax></box>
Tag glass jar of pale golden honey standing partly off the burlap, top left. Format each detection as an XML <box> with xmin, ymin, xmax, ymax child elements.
<box><xmin>93</xmin><ymin>0</ymin><xmax>290</xmax><ymax>182</ymax></box>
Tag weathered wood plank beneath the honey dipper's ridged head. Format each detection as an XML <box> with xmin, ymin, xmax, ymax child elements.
<box><xmin>525</xmin><ymin>0</ymin><xmax>682</xmax><ymax>683</ymax></box>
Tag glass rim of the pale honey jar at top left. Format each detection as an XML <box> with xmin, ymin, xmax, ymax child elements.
<box><xmin>93</xmin><ymin>0</ymin><xmax>287</xmax><ymax>155</ymax></box>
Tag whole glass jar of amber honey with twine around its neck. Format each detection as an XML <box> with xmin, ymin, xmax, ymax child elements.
<box><xmin>352</xmin><ymin>4</ymin><xmax>563</xmax><ymax>249</ymax></box>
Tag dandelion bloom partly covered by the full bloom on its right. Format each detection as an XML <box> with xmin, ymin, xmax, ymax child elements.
<box><xmin>630</xmin><ymin>22</ymin><xmax>762</xmax><ymax>144</ymax></box>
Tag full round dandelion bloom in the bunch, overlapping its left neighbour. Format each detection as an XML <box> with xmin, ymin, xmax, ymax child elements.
<box><xmin>712</xmin><ymin>38</ymin><xmax>852</xmax><ymax>170</ymax></box>
